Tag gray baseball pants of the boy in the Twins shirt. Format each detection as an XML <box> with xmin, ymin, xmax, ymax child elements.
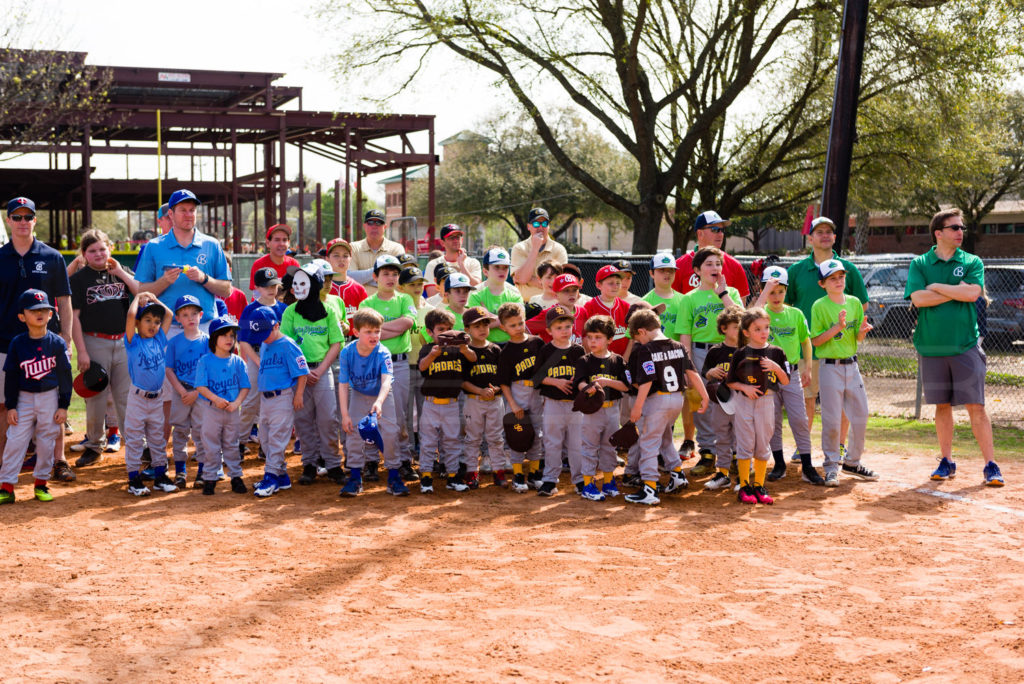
<box><xmin>0</xmin><ymin>389</ymin><xmax>63</xmax><ymax>484</ymax></box>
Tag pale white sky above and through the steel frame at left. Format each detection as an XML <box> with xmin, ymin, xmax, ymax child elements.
<box><xmin>6</xmin><ymin>0</ymin><xmax>503</xmax><ymax>197</ymax></box>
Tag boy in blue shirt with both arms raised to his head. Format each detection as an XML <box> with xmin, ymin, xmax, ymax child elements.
<box><xmin>123</xmin><ymin>292</ymin><xmax>178</xmax><ymax>497</ymax></box>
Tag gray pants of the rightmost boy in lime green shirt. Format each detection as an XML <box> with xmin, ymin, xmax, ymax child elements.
<box><xmin>818</xmin><ymin>358</ymin><xmax>867</xmax><ymax>475</ymax></box>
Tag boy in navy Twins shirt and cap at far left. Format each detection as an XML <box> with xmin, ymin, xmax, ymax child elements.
<box><xmin>0</xmin><ymin>290</ymin><xmax>71</xmax><ymax>504</ymax></box>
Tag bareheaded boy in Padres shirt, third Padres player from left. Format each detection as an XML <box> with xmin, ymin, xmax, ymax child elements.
<box><xmin>498</xmin><ymin>302</ymin><xmax>544</xmax><ymax>494</ymax></box>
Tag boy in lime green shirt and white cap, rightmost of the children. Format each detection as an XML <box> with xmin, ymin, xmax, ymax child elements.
<box><xmin>811</xmin><ymin>259</ymin><xmax>879</xmax><ymax>486</ymax></box>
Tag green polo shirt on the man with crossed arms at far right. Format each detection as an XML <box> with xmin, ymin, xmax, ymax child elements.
<box><xmin>903</xmin><ymin>247</ymin><xmax>985</xmax><ymax>356</ymax></box>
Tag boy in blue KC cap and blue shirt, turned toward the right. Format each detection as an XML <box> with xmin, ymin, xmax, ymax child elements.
<box><xmin>249</xmin><ymin>306</ymin><xmax>309</xmax><ymax>499</ymax></box>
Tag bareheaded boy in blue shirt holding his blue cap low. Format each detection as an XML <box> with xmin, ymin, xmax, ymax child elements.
<box><xmin>338</xmin><ymin>308</ymin><xmax>409</xmax><ymax>497</ymax></box>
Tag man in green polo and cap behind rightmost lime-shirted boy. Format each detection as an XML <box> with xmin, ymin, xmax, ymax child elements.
<box><xmin>785</xmin><ymin>216</ymin><xmax>867</xmax><ymax>456</ymax></box>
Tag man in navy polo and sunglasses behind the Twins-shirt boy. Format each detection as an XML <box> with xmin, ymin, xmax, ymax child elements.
<box><xmin>0</xmin><ymin>197</ymin><xmax>75</xmax><ymax>482</ymax></box>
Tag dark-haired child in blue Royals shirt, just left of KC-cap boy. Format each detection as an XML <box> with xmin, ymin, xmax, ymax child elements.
<box><xmin>196</xmin><ymin>316</ymin><xmax>250</xmax><ymax>495</ymax></box>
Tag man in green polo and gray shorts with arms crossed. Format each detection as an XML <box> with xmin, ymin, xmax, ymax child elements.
<box><xmin>903</xmin><ymin>209</ymin><xmax>1004</xmax><ymax>486</ymax></box>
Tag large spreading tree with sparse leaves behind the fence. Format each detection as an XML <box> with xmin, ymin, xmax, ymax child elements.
<box><xmin>321</xmin><ymin>0</ymin><xmax>1021</xmax><ymax>252</ymax></box>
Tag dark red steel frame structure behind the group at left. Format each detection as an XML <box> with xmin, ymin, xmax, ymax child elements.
<box><xmin>0</xmin><ymin>50</ymin><xmax>437</xmax><ymax>252</ymax></box>
